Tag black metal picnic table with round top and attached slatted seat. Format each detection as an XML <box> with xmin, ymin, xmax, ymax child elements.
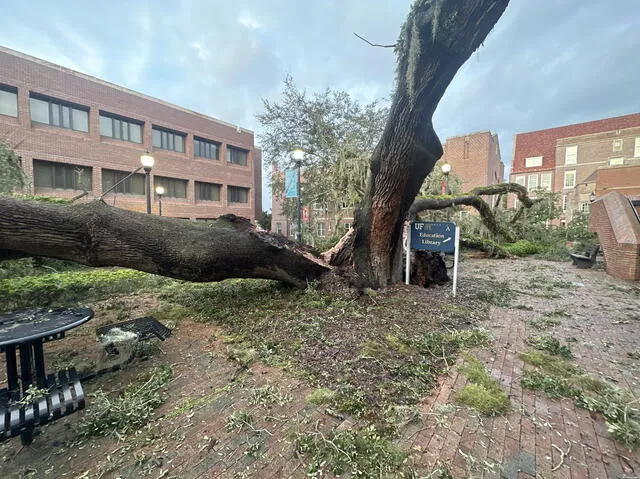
<box><xmin>0</xmin><ymin>308</ymin><xmax>93</xmax><ymax>444</ymax></box>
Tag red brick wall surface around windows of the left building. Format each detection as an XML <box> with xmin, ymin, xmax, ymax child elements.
<box><xmin>0</xmin><ymin>47</ymin><xmax>262</xmax><ymax>220</ymax></box>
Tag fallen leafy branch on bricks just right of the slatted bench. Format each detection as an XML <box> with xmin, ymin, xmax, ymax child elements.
<box><xmin>78</xmin><ymin>366</ymin><xmax>173</xmax><ymax>437</ymax></box>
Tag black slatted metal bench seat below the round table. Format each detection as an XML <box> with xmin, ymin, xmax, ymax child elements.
<box><xmin>0</xmin><ymin>368</ymin><xmax>85</xmax><ymax>444</ymax></box>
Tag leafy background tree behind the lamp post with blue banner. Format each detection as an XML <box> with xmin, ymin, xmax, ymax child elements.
<box><xmin>257</xmin><ymin>76</ymin><xmax>389</xmax><ymax>219</ymax></box>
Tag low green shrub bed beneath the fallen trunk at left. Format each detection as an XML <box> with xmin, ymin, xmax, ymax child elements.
<box><xmin>0</xmin><ymin>269</ymin><xmax>165</xmax><ymax>311</ymax></box>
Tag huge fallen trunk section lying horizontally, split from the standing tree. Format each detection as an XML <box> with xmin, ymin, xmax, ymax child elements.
<box><xmin>0</xmin><ymin>197</ymin><xmax>329</xmax><ymax>286</ymax></box>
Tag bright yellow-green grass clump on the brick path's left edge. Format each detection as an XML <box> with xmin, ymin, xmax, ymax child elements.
<box><xmin>455</xmin><ymin>355</ymin><xmax>510</xmax><ymax>416</ymax></box>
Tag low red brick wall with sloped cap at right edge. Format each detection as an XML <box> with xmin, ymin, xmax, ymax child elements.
<box><xmin>589</xmin><ymin>192</ymin><xmax>640</xmax><ymax>281</ymax></box>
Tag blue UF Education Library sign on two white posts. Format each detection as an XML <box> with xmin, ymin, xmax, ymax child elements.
<box><xmin>406</xmin><ymin>221</ymin><xmax>460</xmax><ymax>298</ymax></box>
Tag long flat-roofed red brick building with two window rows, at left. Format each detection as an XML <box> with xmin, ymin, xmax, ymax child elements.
<box><xmin>0</xmin><ymin>47</ymin><xmax>262</xmax><ymax>220</ymax></box>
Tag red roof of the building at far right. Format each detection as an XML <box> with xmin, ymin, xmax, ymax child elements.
<box><xmin>511</xmin><ymin>113</ymin><xmax>640</xmax><ymax>173</ymax></box>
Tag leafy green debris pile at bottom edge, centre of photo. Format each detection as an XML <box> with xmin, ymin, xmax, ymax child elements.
<box><xmin>296</xmin><ymin>426</ymin><xmax>409</xmax><ymax>478</ymax></box>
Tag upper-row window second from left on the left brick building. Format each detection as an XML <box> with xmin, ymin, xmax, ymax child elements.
<box><xmin>29</xmin><ymin>93</ymin><xmax>89</xmax><ymax>132</ymax></box>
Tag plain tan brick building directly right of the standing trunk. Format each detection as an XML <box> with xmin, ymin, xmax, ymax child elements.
<box><xmin>440</xmin><ymin>131</ymin><xmax>504</xmax><ymax>192</ymax></box>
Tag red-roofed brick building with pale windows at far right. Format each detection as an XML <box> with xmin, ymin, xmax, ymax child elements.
<box><xmin>509</xmin><ymin>114</ymin><xmax>640</xmax><ymax>223</ymax></box>
